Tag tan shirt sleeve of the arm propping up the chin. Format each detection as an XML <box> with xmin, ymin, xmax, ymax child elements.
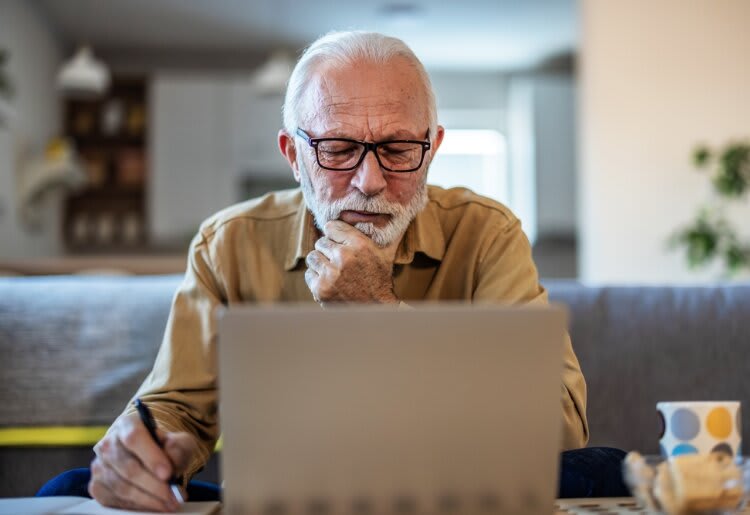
<box><xmin>473</xmin><ymin>219</ymin><xmax>589</xmax><ymax>450</ymax></box>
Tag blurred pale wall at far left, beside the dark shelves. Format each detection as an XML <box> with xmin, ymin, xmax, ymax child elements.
<box><xmin>0</xmin><ymin>0</ymin><xmax>62</xmax><ymax>259</ymax></box>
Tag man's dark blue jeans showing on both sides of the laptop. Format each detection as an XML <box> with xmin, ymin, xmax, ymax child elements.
<box><xmin>36</xmin><ymin>447</ymin><xmax>630</xmax><ymax>501</ymax></box>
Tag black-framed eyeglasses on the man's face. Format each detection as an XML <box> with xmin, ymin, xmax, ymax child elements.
<box><xmin>296</xmin><ymin>128</ymin><xmax>431</xmax><ymax>172</ymax></box>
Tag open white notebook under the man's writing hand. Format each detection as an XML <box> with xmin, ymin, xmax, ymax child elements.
<box><xmin>0</xmin><ymin>497</ymin><xmax>221</xmax><ymax>515</ymax></box>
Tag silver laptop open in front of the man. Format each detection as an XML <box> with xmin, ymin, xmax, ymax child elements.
<box><xmin>219</xmin><ymin>304</ymin><xmax>566</xmax><ymax>515</ymax></box>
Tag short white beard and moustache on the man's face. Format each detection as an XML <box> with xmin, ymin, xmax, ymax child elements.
<box><xmin>297</xmin><ymin>158</ymin><xmax>428</xmax><ymax>248</ymax></box>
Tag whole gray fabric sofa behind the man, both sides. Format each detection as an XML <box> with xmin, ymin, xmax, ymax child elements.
<box><xmin>0</xmin><ymin>275</ymin><xmax>750</xmax><ymax>497</ymax></box>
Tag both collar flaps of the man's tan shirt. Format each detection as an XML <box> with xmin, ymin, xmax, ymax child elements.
<box><xmin>284</xmin><ymin>194</ymin><xmax>445</xmax><ymax>271</ymax></box>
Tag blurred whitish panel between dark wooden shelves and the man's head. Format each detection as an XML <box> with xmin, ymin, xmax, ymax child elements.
<box><xmin>148</xmin><ymin>74</ymin><xmax>236</xmax><ymax>244</ymax></box>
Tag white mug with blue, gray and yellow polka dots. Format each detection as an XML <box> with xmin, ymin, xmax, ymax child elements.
<box><xmin>656</xmin><ymin>401</ymin><xmax>742</xmax><ymax>457</ymax></box>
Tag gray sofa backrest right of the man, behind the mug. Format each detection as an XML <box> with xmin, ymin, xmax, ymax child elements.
<box><xmin>545</xmin><ymin>281</ymin><xmax>750</xmax><ymax>453</ymax></box>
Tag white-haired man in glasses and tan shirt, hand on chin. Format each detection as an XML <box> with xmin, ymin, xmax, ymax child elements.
<box><xmin>42</xmin><ymin>32</ymin><xmax>628</xmax><ymax>510</ymax></box>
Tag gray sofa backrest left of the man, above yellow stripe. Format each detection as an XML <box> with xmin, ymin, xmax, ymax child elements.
<box><xmin>0</xmin><ymin>275</ymin><xmax>181</xmax><ymax>427</ymax></box>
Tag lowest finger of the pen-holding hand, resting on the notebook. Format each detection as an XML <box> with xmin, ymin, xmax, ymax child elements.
<box><xmin>89</xmin><ymin>460</ymin><xmax>179</xmax><ymax>511</ymax></box>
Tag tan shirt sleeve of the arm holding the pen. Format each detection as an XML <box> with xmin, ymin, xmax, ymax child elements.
<box><xmin>108</xmin><ymin>230</ymin><xmax>225</xmax><ymax>480</ymax></box>
